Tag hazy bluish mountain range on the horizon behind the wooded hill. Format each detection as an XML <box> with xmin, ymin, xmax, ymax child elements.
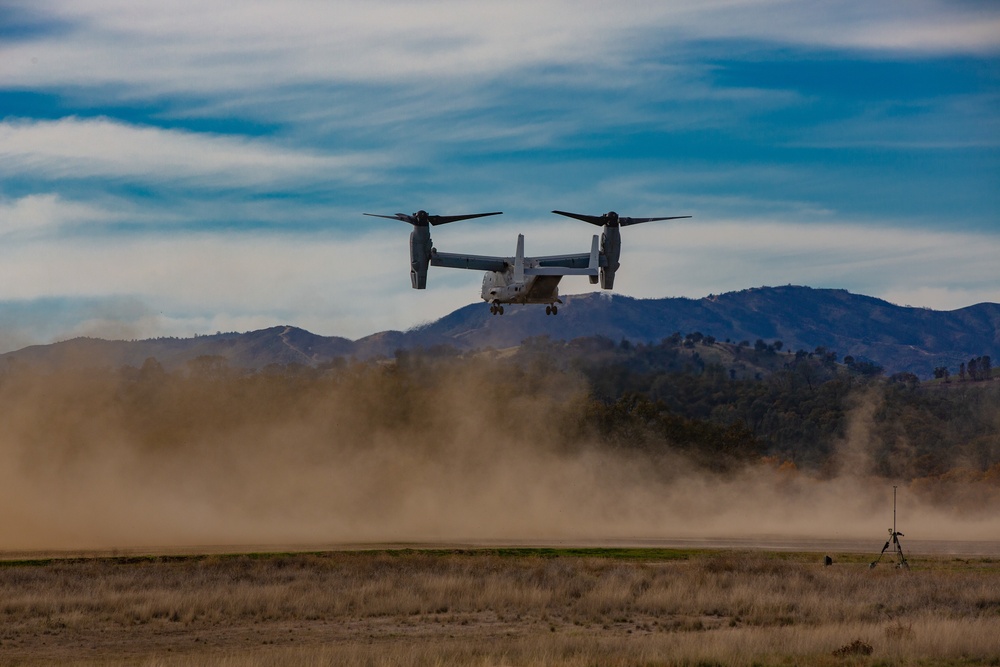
<box><xmin>0</xmin><ymin>285</ymin><xmax>1000</xmax><ymax>377</ymax></box>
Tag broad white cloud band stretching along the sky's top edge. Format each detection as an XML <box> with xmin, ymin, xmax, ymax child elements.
<box><xmin>0</xmin><ymin>0</ymin><xmax>1000</xmax><ymax>94</ymax></box>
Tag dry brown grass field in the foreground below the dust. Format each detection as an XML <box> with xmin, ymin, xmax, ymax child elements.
<box><xmin>0</xmin><ymin>549</ymin><xmax>1000</xmax><ymax>667</ymax></box>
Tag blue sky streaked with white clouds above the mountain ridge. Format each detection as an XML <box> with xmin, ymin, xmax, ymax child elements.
<box><xmin>0</xmin><ymin>0</ymin><xmax>1000</xmax><ymax>351</ymax></box>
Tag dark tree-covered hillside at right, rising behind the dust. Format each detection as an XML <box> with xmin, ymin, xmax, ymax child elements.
<box><xmin>519</xmin><ymin>333</ymin><xmax>1000</xmax><ymax>481</ymax></box>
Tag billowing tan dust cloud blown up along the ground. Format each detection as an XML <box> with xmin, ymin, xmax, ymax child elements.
<box><xmin>0</xmin><ymin>359</ymin><xmax>1000</xmax><ymax>552</ymax></box>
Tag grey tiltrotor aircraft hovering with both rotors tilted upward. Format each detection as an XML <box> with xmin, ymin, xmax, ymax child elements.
<box><xmin>364</xmin><ymin>211</ymin><xmax>691</xmax><ymax>315</ymax></box>
